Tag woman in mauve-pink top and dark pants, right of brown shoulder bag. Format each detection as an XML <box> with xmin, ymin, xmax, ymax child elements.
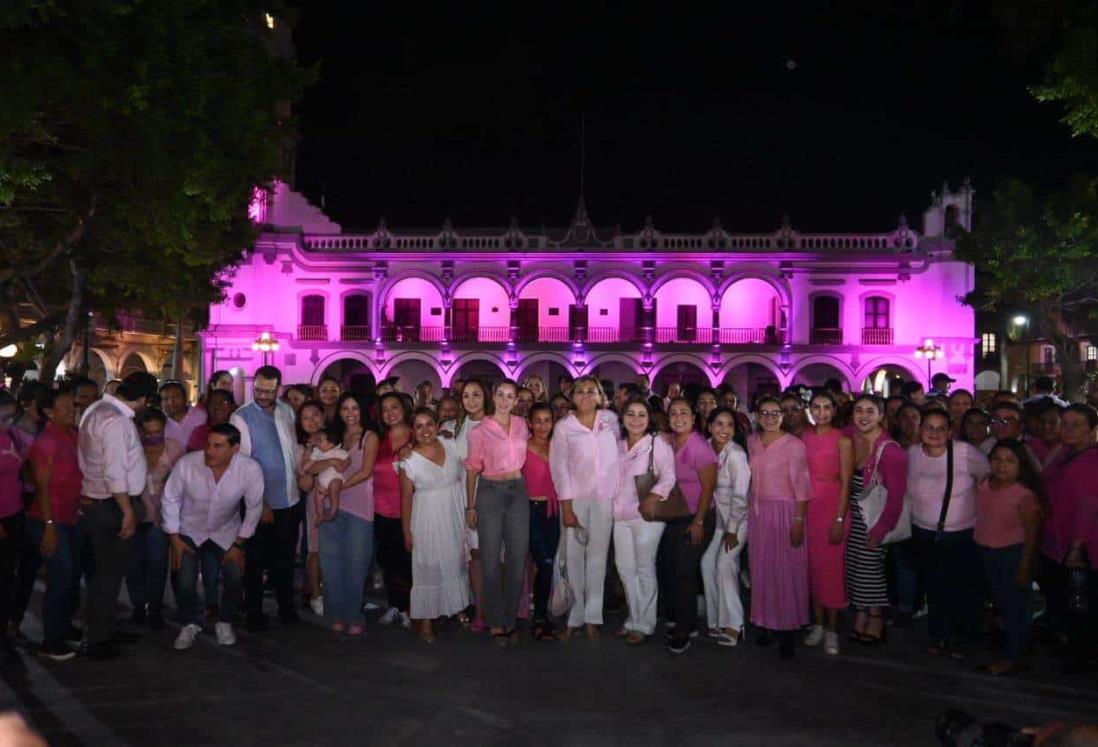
<box><xmin>663</xmin><ymin>397</ymin><xmax>719</xmax><ymax>654</ymax></box>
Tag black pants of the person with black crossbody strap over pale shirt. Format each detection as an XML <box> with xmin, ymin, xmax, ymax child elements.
<box><xmin>911</xmin><ymin>526</ymin><xmax>987</xmax><ymax>643</ymax></box>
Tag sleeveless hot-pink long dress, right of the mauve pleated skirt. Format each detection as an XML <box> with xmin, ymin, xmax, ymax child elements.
<box><xmin>804</xmin><ymin>428</ymin><xmax>850</xmax><ymax>610</ymax></box>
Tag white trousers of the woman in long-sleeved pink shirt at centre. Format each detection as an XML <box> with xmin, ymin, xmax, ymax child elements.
<box><xmin>564</xmin><ymin>501</ymin><xmax>614</xmax><ymax>627</ymax></box>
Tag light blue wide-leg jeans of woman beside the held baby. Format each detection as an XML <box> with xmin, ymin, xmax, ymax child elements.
<box><xmin>320</xmin><ymin>510</ymin><xmax>373</xmax><ymax>623</ymax></box>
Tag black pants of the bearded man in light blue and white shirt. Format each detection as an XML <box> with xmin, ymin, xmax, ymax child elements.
<box><xmin>244</xmin><ymin>501</ymin><xmax>304</xmax><ymax>621</ymax></box>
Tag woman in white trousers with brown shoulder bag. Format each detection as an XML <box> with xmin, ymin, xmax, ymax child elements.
<box><xmin>614</xmin><ymin>400</ymin><xmax>675</xmax><ymax>646</ymax></box>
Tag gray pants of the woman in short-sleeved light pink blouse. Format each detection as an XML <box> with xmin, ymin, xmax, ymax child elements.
<box><xmin>477</xmin><ymin>477</ymin><xmax>530</xmax><ymax>631</ymax></box>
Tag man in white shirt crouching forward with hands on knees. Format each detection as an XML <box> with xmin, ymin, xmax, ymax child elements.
<box><xmin>160</xmin><ymin>423</ymin><xmax>264</xmax><ymax>650</ymax></box>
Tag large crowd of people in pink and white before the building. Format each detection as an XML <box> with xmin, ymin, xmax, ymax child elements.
<box><xmin>0</xmin><ymin>366</ymin><xmax>1098</xmax><ymax>676</ymax></box>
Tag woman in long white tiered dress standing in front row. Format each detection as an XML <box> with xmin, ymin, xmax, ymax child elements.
<box><xmin>399</xmin><ymin>408</ymin><xmax>469</xmax><ymax>643</ymax></box>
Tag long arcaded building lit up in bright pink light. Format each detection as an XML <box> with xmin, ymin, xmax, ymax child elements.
<box><xmin>201</xmin><ymin>183</ymin><xmax>975</xmax><ymax>397</ymax></box>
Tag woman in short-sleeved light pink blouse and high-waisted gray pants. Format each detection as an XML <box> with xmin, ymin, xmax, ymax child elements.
<box><xmin>466</xmin><ymin>379</ymin><xmax>530</xmax><ymax>647</ymax></box>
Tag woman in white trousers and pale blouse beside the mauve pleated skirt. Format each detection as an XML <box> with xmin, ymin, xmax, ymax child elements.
<box><xmin>702</xmin><ymin>408</ymin><xmax>751</xmax><ymax>646</ymax></box>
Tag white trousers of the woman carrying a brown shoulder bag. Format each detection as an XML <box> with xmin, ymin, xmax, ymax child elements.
<box><xmin>614</xmin><ymin>519</ymin><xmax>663</xmax><ymax>635</ymax></box>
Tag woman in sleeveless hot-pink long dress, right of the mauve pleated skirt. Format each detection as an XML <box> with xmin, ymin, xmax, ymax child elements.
<box><xmin>803</xmin><ymin>389</ymin><xmax>854</xmax><ymax>656</ymax></box>
